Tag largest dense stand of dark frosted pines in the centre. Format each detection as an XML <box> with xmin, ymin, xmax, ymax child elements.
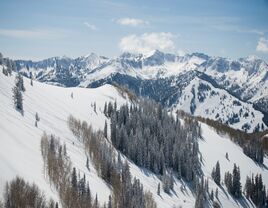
<box><xmin>104</xmin><ymin>100</ymin><xmax>201</xmax><ymax>186</ymax></box>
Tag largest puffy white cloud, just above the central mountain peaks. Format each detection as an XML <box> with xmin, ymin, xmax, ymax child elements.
<box><xmin>119</xmin><ymin>32</ymin><xmax>175</xmax><ymax>54</ymax></box>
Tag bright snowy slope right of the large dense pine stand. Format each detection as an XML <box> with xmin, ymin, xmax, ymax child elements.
<box><xmin>199</xmin><ymin>124</ymin><xmax>268</xmax><ymax>207</ymax></box>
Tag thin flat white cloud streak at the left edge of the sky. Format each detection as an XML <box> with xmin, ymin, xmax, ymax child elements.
<box><xmin>0</xmin><ymin>29</ymin><xmax>66</xmax><ymax>39</ymax></box>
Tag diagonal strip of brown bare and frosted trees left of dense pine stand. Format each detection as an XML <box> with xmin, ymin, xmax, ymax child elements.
<box><xmin>68</xmin><ymin>116</ymin><xmax>155</xmax><ymax>208</ymax></box>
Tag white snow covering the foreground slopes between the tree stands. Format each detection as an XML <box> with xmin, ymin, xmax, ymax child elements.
<box><xmin>0</xmin><ymin>70</ymin><xmax>268</xmax><ymax>208</ymax></box>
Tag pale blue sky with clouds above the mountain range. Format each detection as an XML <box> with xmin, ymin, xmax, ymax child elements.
<box><xmin>0</xmin><ymin>0</ymin><xmax>268</xmax><ymax>61</ymax></box>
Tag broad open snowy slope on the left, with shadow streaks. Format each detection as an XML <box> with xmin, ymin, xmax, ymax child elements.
<box><xmin>0</xmin><ymin>69</ymin><xmax>129</xmax><ymax>202</ymax></box>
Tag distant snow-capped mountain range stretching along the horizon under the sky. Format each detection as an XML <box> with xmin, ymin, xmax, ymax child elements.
<box><xmin>16</xmin><ymin>50</ymin><xmax>268</xmax><ymax>131</ymax></box>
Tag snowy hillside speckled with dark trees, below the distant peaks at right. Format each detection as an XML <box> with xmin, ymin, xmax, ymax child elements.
<box><xmin>172</xmin><ymin>78</ymin><xmax>267</xmax><ymax>132</ymax></box>
